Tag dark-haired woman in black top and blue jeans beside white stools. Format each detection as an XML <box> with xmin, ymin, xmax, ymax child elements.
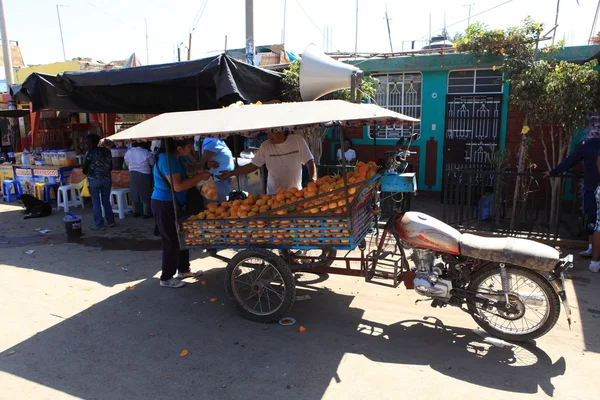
<box><xmin>83</xmin><ymin>133</ymin><xmax>115</xmax><ymax>231</ymax></box>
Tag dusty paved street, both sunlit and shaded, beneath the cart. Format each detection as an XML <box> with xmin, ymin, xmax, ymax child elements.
<box><xmin>0</xmin><ymin>205</ymin><xmax>600</xmax><ymax>399</ymax></box>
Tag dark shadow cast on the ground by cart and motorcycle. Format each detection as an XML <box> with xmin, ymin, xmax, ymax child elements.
<box><xmin>0</xmin><ymin>269</ymin><xmax>566</xmax><ymax>399</ymax></box>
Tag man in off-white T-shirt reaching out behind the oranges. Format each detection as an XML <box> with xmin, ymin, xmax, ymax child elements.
<box><xmin>218</xmin><ymin>131</ymin><xmax>317</xmax><ymax>194</ymax></box>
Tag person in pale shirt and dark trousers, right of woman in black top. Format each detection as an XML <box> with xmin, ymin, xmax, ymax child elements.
<box><xmin>125</xmin><ymin>142</ymin><xmax>154</xmax><ymax>218</ymax></box>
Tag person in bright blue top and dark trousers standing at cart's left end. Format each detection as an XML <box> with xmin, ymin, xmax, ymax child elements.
<box><xmin>151</xmin><ymin>139</ymin><xmax>210</xmax><ymax>288</ymax></box>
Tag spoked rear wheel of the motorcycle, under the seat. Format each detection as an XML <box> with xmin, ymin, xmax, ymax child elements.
<box><xmin>467</xmin><ymin>266</ymin><xmax>560</xmax><ymax>341</ymax></box>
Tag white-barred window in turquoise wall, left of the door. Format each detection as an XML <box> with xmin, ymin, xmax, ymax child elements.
<box><xmin>369</xmin><ymin>72</ymin><xmax>423</xmax><ymax>139</ymax></box>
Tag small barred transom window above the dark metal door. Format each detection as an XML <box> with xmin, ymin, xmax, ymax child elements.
<box><xmin>448</xmin><ymin>69</ymin><xmax>503</xmax><ymax>94</ymax></box>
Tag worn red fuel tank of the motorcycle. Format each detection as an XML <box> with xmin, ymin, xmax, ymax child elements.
<box><xmin>396</xmin><ymin>211</ymin><xmax>461</xmax><ymax>255</ymax></box>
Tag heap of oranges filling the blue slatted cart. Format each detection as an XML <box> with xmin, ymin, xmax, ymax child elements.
<box><xmin>183</xmin><ymin>162</ymin><xmax>378</xmax><ymax>245</ymax></box>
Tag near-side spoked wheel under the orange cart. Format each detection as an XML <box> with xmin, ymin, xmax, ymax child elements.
<box><xmin>225</xmin><ymin>249</ymin><xmax>296</xmax><ymax>322</ymax></box>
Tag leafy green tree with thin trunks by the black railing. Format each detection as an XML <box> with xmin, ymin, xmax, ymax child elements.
<box><xmin>455</xmin><ymin>18</ymin><xmax>599</xmax><ymax>223</ymax></box>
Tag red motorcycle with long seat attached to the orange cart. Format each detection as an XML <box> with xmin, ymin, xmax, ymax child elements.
<box><xmin>379</xmin><ymin>141</ymin><xmax>573</xmax><ymax>341</ymax></box>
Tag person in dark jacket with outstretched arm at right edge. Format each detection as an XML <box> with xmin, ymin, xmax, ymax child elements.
<box><xmin>544</xmin><ymin>129</ymin><xmax>600</xmax><ymax>257</ymax></box>
